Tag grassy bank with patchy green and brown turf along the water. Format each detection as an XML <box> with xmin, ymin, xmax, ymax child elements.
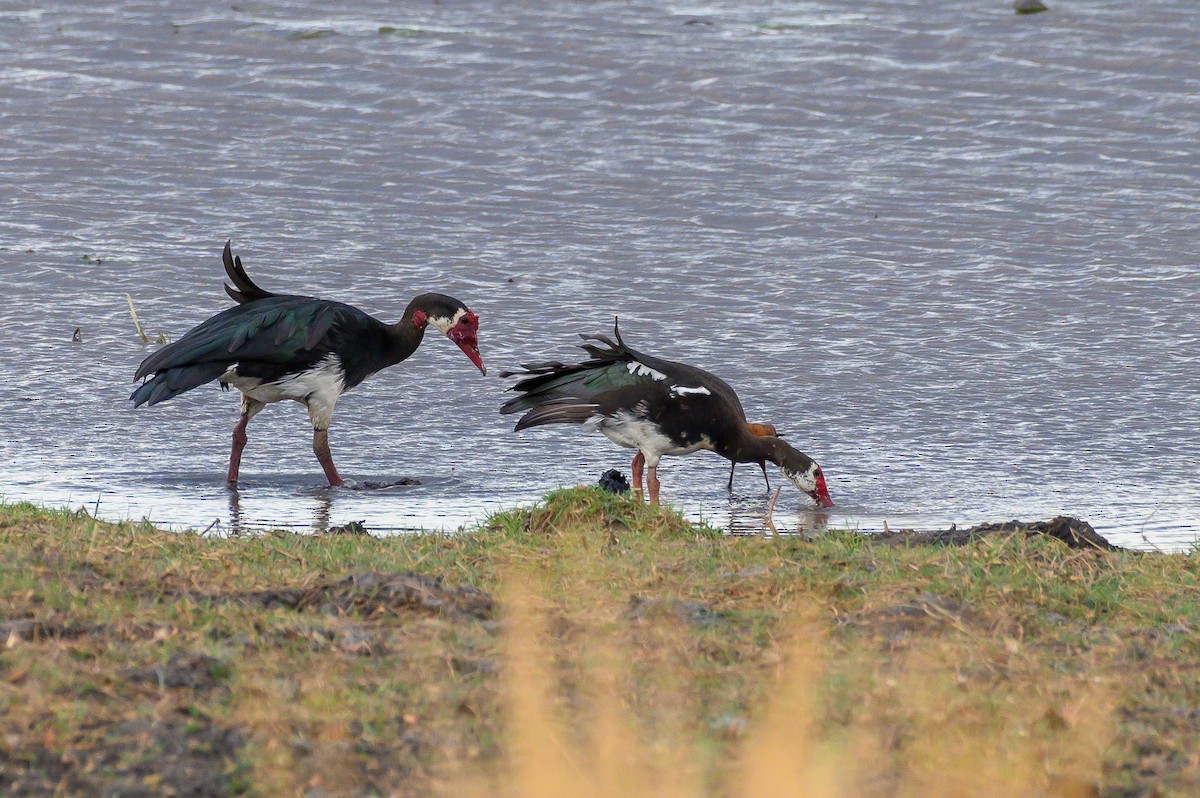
<box><xmin>0</xmin><ymin>490</ymin><xmax>1200</xmax><ymax>798</ymax></box>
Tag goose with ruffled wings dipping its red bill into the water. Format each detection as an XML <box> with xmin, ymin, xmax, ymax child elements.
<box><xmin>500</xmin><ymin>324</ymin><xmax>833</xmax><ymax>508</ymax></box>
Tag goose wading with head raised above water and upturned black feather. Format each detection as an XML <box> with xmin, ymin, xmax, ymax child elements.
<box><xmin>130</xmin><ymin>242</ymin><xmax>487</xmax><ymax>487</ymax></box>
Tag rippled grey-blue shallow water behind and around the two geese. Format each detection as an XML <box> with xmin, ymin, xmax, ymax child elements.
<box><xmin>0</xmin><ymin>0</ymin><xmax>1200</xmax><ymax>548</ymax></box>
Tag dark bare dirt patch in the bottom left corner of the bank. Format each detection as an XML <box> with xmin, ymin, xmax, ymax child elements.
<box><xmin>0</xmin><ymin>716</ymin><xmax>245</xmax><ymax>798</ymax></box>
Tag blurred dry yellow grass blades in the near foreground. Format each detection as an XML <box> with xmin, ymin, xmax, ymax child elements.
<box><xmin>443</xmin><ymin>544</ymin><xmax>1117</xmax><ymax>798</ymax></box>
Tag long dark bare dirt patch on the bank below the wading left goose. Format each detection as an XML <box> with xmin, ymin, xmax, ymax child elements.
<box><xmin>220</xmin><ymin>571</ymin><xmax>493</xmax><ymax>620</ymax></box>
